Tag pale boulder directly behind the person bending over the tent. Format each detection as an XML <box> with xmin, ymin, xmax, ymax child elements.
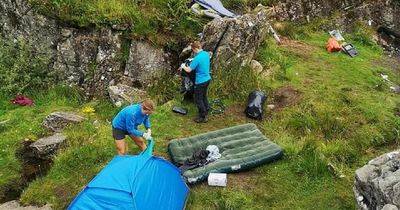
<box><xmin>108</xmin><ymin>84</ymin><xmax>147</xmax><ymax>107</ymax></box>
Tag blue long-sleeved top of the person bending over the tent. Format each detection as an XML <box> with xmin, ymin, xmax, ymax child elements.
<box><xmin>112</xmin><ymin>103</ymin><xmax>150</xmax><ymax>136</ymax></box>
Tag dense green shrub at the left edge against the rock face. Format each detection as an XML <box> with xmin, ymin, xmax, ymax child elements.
<box><xmin>0</xmin><ymin>39</ymin><xmax>52</xmax><ymax>94</ymax></box>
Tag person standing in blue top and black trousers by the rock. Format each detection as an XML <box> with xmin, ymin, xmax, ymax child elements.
<box><xmin>181</xmin><ymin>41</ymin><xmax>211</xmax><ymax>123</ymax></box>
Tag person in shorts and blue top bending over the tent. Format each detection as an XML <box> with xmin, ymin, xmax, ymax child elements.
<box><xmin>112</xmin><ymin>99</ymin><xmax>155</xmax><ymax>155</ymax></box>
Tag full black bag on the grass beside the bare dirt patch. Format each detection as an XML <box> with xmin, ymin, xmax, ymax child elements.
<box><xmin>244</xmin><ymin>90</ymin><xmax>267</xmax><ymax>120</ymax></box>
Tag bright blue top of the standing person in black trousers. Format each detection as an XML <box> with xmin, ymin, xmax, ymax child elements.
<box><xmin>189</xmin><ymin>50</ymin><xmax>211</xmax><ymax>85</ymax></box>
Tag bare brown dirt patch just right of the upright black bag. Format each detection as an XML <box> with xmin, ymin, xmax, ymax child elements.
<box><xmin>273</xmin><ymin>87</ymin><xmax>303</xmax><ymax>111</ymax></box>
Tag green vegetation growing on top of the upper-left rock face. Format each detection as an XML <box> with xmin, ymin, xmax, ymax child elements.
<box><xmin>29</xmin><ymin>0</ymin><xmax>205</xmax><ymax>45</ymax></box>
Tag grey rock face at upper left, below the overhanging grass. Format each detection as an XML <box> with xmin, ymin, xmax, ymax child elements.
<box><xmin>0</xmin><ymin>0</ymin><xmax>170</xmax><ymax>97</ymax></box>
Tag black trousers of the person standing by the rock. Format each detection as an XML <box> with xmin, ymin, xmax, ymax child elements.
<box><xmin>194</xmin><ymin>81</ymin><xmax>210</xmax><ymax>118</ymax></box>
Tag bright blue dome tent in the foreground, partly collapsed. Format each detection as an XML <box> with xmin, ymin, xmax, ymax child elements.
<box><xmin>68</xmin><ymin>140</ymin><xmax>189</xmax><ymax>210</ymax></box>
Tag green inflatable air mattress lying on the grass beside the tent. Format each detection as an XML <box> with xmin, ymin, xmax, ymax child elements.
<box><xmin>168</xmin><ymin>123</ymin><xmax>282</xmax><ymax>184</ymax></box>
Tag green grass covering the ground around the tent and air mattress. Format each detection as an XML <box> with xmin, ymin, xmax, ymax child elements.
<box><xmin>0</xmin><ymin>25</ymin><xmax>400</xmax><ymax>210</ymax></box>
